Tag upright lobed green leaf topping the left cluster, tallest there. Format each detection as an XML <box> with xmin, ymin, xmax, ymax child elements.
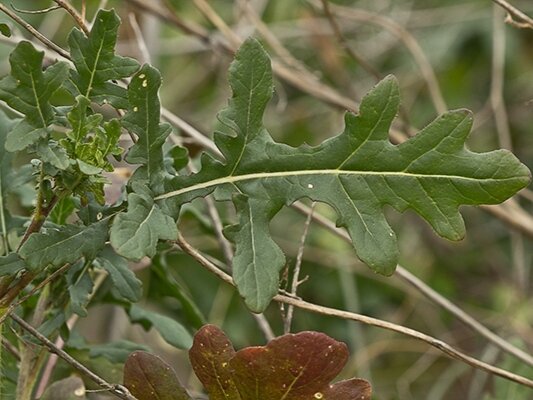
<box><xmin>68</xmin><ymin>10</ymin><xmax>139</xmax><ymax>108</ymax></box>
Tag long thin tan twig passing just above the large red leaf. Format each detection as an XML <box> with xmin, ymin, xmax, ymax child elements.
<box><xmin>177</xmin><ymin>235</ymin><xmax>533</xmax><ymax>388</ymax></box>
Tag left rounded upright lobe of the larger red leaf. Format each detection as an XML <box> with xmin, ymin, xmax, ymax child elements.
<box><xmin>189</xmin><ymin>325</ymin><xmax>241</xmax><ymax>400</ymax></box>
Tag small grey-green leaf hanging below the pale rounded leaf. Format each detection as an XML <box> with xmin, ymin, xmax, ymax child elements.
<box><xmin>96</xmin><ymin>246</ymin><xmax>142</xmax><ymax>302</ymax></box>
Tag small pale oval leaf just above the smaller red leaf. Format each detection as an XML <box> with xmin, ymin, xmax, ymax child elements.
<box><xmin>129</xmin><ymin>305</ymin><xmax>192</xmax><ymax>349</ymax></box>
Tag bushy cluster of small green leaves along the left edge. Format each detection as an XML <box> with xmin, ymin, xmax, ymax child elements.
<box><xmin>0</xmin><ymin>11</ymin><xmax>191</xmax><ymax>378</ymax></box>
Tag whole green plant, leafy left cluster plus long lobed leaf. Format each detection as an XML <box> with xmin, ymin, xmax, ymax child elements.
<box><xmin>0</xmin><ymin>5</ymin><xmax>530</xmax><ymax>398</ymax></box>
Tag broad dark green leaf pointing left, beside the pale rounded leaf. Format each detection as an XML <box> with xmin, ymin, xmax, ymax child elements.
<box><xmin>19</xmin><ymin>219</ymin><xmax>108</xmax><ymax>271</ymax></box>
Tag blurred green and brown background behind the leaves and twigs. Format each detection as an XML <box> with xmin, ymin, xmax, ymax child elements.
<box><xmin>0</xmin><ymin>0</ymin><xmax>533</xmax><ymax>400</ymax></box>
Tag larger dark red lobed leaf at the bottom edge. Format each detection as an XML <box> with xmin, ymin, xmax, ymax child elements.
<box><xmin>189</xmin><ymin>325</ymin><xmax>372</xmax><ymax>400</ymax></box>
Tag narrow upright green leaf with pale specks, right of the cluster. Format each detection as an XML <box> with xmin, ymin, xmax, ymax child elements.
<box><xmin>122</xmin><ymin>65</ymin><xmax>171</xmax><ymax>190</ymax></box>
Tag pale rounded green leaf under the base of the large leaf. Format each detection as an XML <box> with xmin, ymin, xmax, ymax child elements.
<box><xmin>110</xmin><ymin>193</ymin><xmax>178</xmax><ymax>260</ymax></box>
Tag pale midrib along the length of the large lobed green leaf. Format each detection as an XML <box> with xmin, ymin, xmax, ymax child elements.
<box><xmin>154</xmin><ymin>169</ymin><xmax>522</xmax><ymax>200</ymax></box>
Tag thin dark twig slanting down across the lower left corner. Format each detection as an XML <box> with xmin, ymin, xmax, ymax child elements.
<box><xmin>11</xmin><ymin>314</ymin><xmax>137</xmax><ymax>400</ymax></box>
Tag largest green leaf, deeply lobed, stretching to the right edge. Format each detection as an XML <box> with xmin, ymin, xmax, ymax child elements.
<box><xmin>160</xmin><ymin>39</ymin><xmax>531</xmax><ymax>312</ymax></box>
